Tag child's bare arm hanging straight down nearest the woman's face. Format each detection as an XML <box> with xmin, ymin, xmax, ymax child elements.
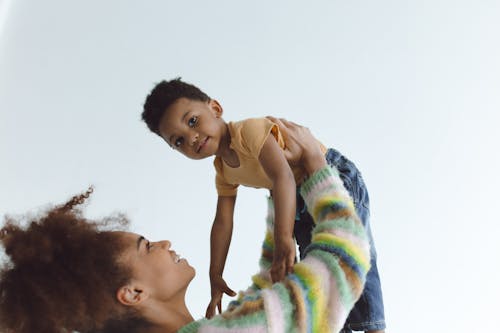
<box><xmin>205</xmin><ymin>196</ymin><xmax>236</xmax><ymax>318</ymax></box>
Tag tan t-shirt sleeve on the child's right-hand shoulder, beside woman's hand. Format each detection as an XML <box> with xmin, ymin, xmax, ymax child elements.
<box><xmin>232</xmin><ymin>118</ymin><xmax>285</xmax><ymax>159</ymax></box>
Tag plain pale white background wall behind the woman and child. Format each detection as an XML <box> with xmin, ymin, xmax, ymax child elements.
<box><xmin>0</xmin><ymin>0</ymin><xmax>500</xmax><ymax>332</ymax></box>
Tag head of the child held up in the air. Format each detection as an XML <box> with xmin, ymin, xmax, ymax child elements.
<box><xmin>142</xmin><ymin>78</ymin><xmax>226</xmax><ymax>159</ymax></box>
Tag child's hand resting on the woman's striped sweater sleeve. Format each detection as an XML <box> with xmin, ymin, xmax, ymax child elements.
<box><xmin>271</xmin><ymin>237</ymin><xmax>295</xmax><ymax>283</ymax></box>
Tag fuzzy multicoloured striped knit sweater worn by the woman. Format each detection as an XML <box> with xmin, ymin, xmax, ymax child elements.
<box><xmin>179</xmin><ymin>167</ymin><xmax>370</xmax><ymax>333</ymax></box>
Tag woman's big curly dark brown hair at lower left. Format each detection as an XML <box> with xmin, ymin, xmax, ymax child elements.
<box><xmin>0</xmin><ymin>188</ymin><xmax>146</xmax><ymax>333</ymax></box>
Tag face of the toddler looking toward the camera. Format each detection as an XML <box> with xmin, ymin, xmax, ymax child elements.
<box><xmin>159</xmin><ymin>97</ymin><xmax>226</xmax><ymax>160</ymax></box>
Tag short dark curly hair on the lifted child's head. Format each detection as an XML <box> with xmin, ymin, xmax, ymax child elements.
<box><xmin>142</xmin><ymin>77</ymin><xmax>210</xmax><ymax>136</ymax></box>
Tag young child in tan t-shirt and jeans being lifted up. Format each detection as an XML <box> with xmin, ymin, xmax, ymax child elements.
<box><xmin>142</xmin><ymin>78</ymin><xmax>385</xmax><ymax>332</ymax></box>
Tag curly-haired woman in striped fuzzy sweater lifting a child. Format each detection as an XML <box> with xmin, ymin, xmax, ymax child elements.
<box><xmin>0</xmin><ymin>120</ymin><xmax>370</xmax><ymax>333</ymax></box>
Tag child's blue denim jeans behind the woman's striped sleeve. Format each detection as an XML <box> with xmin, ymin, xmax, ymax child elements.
<box><xmin>293</xmin><ymin>148</ymin><xmax>385</xmax><ymax>333</ymax></box>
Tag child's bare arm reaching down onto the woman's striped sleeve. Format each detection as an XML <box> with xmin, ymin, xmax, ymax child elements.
<box><xmin>259</xmin><ymin>135</ymin><xmax>296</xmax><ymax>282</ymax></box>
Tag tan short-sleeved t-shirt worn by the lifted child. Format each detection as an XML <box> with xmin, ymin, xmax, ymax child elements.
<box><xmin>214</xmin><ymin>118</ymin><xmax>326</xmax><ymax>196</ymax></box>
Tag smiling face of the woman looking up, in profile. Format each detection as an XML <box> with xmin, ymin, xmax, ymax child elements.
<box><xmin>120</xmin><ymin>232</ymin><xmax>195</xmax><ymax>301</ymax></box>
